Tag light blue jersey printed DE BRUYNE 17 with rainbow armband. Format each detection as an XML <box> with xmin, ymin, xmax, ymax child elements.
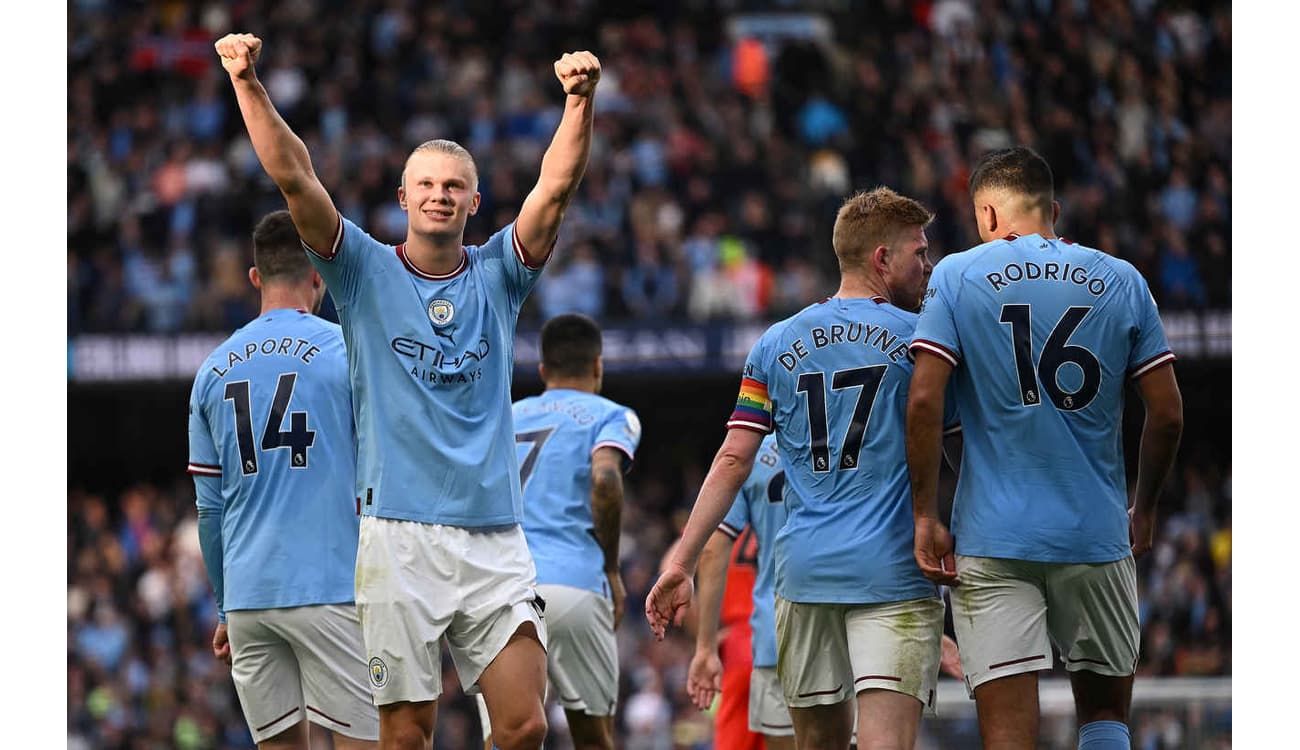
<box><xmin>727</xmin><ymin>298</ymin><xmax>951</xmax><ymax>604</ymax></box>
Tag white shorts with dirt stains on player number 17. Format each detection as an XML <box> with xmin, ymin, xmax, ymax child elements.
<box><xmin>776</xmin><ymin>597</ymin><xmax>944</xmax><ymax>712</ymax></box>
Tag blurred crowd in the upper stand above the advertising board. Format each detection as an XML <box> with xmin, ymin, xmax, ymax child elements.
<box><xmin>68</xmin><ymin>0</ymin><xmax>1231</xmax><ymax>334</ymax></box>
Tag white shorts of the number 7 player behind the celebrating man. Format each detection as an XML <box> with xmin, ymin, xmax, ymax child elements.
<box><xmin>537</xmin><ymin>585</ymin><xmax>619</xmax><ymax>716</ymax></box>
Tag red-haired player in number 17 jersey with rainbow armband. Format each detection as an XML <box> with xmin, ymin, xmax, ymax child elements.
<box><xmin>646</xmin><ymin>187</ymin><xmax>944</xmax><ymax>749</ymax></box>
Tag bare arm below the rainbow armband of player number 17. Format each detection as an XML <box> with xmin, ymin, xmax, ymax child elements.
<box><xmin>646</xmin><ymin>429</ymin><xmax>763</xmax><ymax>641</ymax></box>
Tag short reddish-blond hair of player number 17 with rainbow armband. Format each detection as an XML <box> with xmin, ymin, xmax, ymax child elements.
<box><xmin>831</xmin><ymin>186</ymin><xmax>935</xmax><ymax>272</ymax></box>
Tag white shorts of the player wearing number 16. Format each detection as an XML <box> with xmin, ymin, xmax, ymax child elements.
<box><xmin>949</xmin><ymin>555</ymin><xmax>1139</xmax><ymax>695</ymax></box>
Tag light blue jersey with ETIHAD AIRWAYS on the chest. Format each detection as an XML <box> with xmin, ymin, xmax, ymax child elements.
<box><xmin>308</xmin><ymin>213</ymin><xmax>541</xmax><ymax>528</ymax></box>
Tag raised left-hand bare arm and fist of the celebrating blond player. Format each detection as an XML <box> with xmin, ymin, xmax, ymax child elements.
<box><xmin>216</xmin><ymin>34</ymin><xmax>339</xmax><ymax>255</ymax></box>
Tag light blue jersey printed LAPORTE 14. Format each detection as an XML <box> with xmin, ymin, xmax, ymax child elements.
<box><xmin>189</xmin><ymin>309</ymin><xmax>358</xmax><ymax>611</ymax></box>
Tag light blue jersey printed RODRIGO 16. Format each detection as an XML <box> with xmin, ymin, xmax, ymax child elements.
<box><xmin>913</xmin><ymin>234</ymin><xmax>1174</xmax><ymax>563</ymax></box>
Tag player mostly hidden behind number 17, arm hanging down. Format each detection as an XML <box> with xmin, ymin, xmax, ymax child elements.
<box><xmin>686</xmin><ymin>435</ymin><xmax>794</xmax><ymax>750</ymax></box>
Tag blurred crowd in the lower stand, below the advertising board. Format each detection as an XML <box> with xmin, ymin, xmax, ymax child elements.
<box><xmin>68</xmin><ymin>445</ymin><xmax>1232</xmax><ymax>750</ymax></box>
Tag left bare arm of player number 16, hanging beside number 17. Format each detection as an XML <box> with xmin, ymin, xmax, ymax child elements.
<box><xmin>907</xmin><ymin>351</ymin><xmax>957</xmax><ymax>586</ymax></box>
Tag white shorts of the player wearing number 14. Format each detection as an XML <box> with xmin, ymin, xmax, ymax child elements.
<box><xmin>226</xmin><ymin>604</ymin><xmax>380</xmax><ymax>742</ymax></box>
